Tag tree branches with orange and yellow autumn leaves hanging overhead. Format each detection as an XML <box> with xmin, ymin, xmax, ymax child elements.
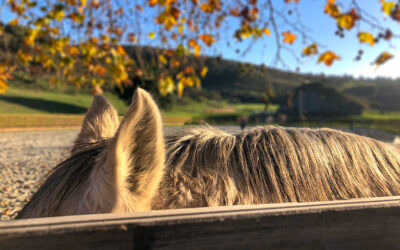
<box><xmin>0</xmin><ymin>0</ymin><xmax>400</xmax><ymax>96</ymax></box>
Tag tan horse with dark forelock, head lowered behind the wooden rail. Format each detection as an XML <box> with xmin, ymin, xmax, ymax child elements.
<box><xmin>17</xmin><ymin>88</ymin><xmax>400</xmax><ymax>218</ymax></box>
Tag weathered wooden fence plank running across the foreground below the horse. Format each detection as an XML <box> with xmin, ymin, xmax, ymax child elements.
<box><xmin>0</xmin><ymin>196</ymin><xmax>400</xmax><ymax>249</ymax></box>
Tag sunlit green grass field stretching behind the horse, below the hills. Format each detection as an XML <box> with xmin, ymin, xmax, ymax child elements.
<box><xmin>0</xmin><ymin>87</ymin><xmax>400</xmax><ymax>134</ymax></box>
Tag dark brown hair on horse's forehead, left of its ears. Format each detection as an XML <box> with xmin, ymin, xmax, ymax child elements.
<box><xmin>16</xmin><ymin>140</ymin><xmax>108</xmax><ymax>219</ymax></box>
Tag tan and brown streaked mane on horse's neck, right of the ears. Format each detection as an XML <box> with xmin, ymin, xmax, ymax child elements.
<box><xmin>154</xmin><ymin>127</ymin><xmax>400</xmax><ymax>209</ymax></box>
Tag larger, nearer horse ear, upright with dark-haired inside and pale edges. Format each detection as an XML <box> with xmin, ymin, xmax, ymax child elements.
<box><xmin>94</xmin><ymin>88</ymin><xmax>165</xmax><ymax>212</ymax></box>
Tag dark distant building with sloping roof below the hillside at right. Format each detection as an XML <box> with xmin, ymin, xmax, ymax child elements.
<box><xmin>278</xmin><ymin>83</ymin><xmax>363</xmax><ymax>117</ymax></box>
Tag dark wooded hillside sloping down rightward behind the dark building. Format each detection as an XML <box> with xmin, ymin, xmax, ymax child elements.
<box><xmin>202</xmin><ymin>58</ymin><xmax>400</xmax><ymax>111</ymax></box>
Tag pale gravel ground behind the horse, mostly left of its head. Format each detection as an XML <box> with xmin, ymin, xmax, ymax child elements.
<box><xmin>0</xmin><ymin>126</ymin><xmax>400</xmax><ymax>220</ymax></box>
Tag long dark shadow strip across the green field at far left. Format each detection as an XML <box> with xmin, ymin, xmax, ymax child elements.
<box><xmin>0</xmin><ymin>96</ymin><xmax>86</xmax><ymax>114</ymax></box>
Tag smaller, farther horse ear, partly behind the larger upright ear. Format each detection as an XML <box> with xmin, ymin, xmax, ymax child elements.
<box><xmin>71</xmin><ymin>95</ymin><xmax>119</xmax><ymax>154</ymax></box>
